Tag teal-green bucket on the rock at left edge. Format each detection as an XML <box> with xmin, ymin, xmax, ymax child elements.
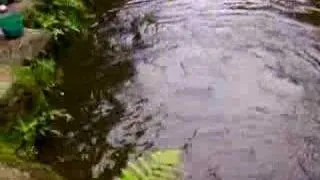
<box><xmin>0</xmin><ymin>12</ymin><xmax>24</xmax><ymax>39</ymax></box>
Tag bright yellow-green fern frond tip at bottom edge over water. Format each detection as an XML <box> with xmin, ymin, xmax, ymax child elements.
<box><xmin>118</xmin><ymin>149</ymin><xmax>182</xmax><ymax>180</ymax></box>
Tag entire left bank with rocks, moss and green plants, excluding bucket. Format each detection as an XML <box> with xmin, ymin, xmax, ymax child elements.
<box><xmin>0</xmin><ymin>0</ymin><xmax>89</xmax><ymax>180</ymax></box>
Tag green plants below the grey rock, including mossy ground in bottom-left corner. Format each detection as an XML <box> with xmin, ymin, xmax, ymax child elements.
<box><xmin>0</xmin><ymin>59</ymin><xmax>69</xmax><ymax>180</ymax></box>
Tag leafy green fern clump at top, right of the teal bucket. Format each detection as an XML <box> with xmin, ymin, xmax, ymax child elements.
<box><xmin>25</xmin><ymin>0</ymin><xmax>88</xmax><ymax>40</ymax></box>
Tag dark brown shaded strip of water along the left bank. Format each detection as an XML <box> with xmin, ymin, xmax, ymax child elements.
<box><xmin>38</xmin><ymin>5</ymin><xmax>140</xmax><ymax>180</ymax></box>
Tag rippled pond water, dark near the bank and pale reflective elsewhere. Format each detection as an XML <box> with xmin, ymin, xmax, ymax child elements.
<box><xmin>39</xmin><ymin>0</ymin><xmax>320</xmax><ymax>180</ymax></box>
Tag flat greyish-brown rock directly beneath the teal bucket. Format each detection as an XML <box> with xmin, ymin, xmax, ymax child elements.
<box><xmin>0</xmin><ymin>28</ymin><xmax>51</xmax><ymax>65</ymax></box>
